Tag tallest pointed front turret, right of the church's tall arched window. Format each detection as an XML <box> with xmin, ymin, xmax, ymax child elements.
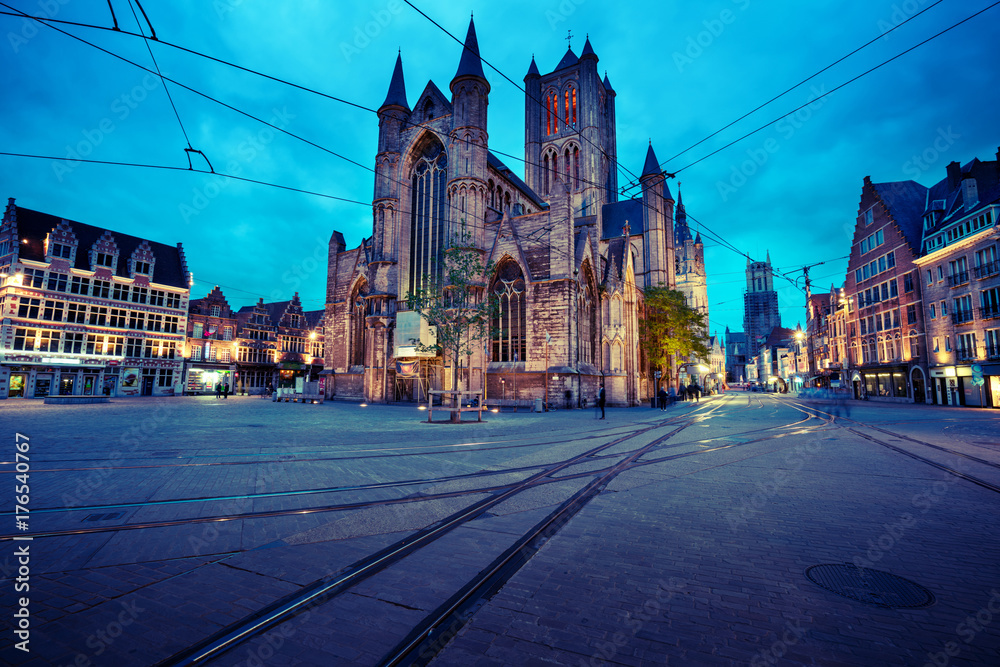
<box><xmin>448</xmin><ymin>20</ymin><xmax>490</xmax><ymax>248</ymax></box>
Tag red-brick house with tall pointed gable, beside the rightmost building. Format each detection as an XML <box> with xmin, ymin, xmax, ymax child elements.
<box><xmin>844</xmin><ymin>176</ymin><xmax>928</xmax><ymax>403</ymax></box>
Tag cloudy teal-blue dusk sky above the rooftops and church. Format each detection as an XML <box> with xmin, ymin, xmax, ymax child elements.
<box><xmin>0</xmin><ymin>0</ymin><xmax>1000</xmax><ymax>333</ymax></box>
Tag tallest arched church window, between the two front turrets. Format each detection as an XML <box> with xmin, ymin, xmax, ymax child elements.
<box><xmin>409</xmin><ymin>139</ymin><xmax>448</xmax><ymax>292</ymax></box>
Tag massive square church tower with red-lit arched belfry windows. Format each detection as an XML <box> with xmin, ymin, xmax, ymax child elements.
<box><xmin>524</xmin><ymin>38</ymin><xmax>618</xmax><ymax>217</ymax></box>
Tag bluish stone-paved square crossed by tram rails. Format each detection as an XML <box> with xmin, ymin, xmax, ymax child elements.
<box><xmin>0</xmin><ymin>393</ymin><xmax>1000</xmax><ymax>665</ymax></box>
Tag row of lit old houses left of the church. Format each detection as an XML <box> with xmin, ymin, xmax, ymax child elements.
<box><xmin>0</xmin><ymin>199</ymin><xmax>324</xmax><ymax>398</ymax></box>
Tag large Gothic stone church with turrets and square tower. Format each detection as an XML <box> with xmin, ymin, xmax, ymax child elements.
<box><xmin>325</xmin><ymin>22</ymin><xmax>676</xmax><ymax>405</ymax></box>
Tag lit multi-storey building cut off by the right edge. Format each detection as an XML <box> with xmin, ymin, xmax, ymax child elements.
<box><xmin>915</xmin><ymin>150</ymin><xmax>1000</xmax><ymax>408</ymax></box>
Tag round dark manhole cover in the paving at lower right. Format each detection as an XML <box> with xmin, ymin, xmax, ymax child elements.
<box><xmin>806</xmin><ymin>563</ymin><xmax>934</xmax><ymax>609</ymax></box>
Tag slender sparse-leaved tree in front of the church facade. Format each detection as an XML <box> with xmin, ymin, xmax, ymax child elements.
<box><xmin>406</xmin><ymin>228</ymin><xmax>497</xmax><ymax>405</ymax></box>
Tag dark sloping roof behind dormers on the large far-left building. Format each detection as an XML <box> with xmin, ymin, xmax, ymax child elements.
<box><xmin>7</xmin><ymin>205</ymin><xmax>189</xmax><ymax>289</ymax></box>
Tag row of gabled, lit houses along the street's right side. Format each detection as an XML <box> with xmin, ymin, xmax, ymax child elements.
<box><xmin>792</xmin><ymin>150</ymin><xmax>1000</xmax><ymax>408</ymax></box>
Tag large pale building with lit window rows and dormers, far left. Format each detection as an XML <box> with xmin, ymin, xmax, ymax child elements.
<box><xmin>0</xmin><ymin>198</ymin><xmax>191</xmax><ymax>398</ymax></box>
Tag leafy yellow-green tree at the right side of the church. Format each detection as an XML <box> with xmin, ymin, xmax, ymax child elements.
<box><xmin>639</xmin><ymin>283</ymin><xmax>711</xmax><ymax>384</ymax></box>
